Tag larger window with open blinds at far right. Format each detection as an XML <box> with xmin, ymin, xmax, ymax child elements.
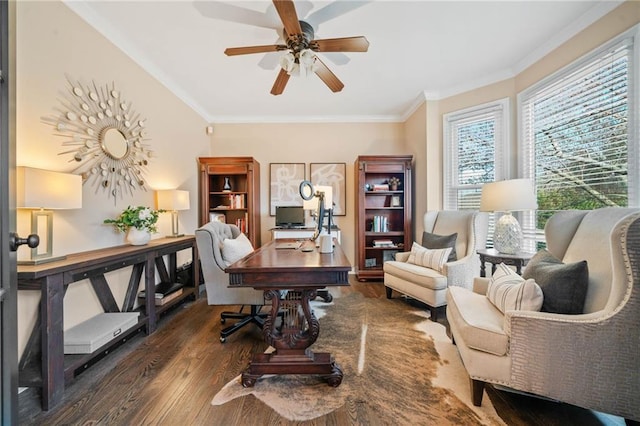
<box><xmin>519</xmin><ymin>26</ymin><xmax>640</xmax><ymax>248</ymax></box>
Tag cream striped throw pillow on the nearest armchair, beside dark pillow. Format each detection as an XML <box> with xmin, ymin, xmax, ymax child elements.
<box><xmin>487</xmin><ymin>263</ymin><xmax>543</xmax><ymax>313</ymax></box>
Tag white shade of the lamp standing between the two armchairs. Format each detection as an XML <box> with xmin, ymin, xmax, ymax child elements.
<box><xmin>480</xmin><ymin>179</ymin><xmax>538</xmax><ymax>212</ymax></box>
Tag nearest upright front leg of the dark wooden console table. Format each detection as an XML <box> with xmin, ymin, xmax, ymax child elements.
<box><xmin>40</xmin><ymin>274</ymin><xmax>64</xmax><ymax>410</ymax></box>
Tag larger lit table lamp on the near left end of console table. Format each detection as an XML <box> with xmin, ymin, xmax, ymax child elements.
<box><xmin>16</xmin><ymin>166</ymin><xmax>82</xmax><ymax>265</ymax></box>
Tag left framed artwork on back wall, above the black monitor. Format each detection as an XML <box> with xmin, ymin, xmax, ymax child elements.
<box><xmin>269</xmin><ymin>163</ymin><xmax>306</xmax><ymax>216</ymax></box>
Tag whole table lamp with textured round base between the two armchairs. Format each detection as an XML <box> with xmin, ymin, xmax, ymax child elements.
<box><xmin>480</xmin><ymin>179</ymin><xmax>538</xmax><ymax>254</ymax></box>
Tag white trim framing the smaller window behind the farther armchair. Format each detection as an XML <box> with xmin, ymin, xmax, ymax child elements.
<box><xmin>442</xmin><ymin>98</ymin><xmax>511</xmax><ymax>209</ymax></box>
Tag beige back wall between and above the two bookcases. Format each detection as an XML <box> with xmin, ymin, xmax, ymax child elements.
<box><xmin>211</xmin><ymin>123</ymin><xmax>404</xmax><ymax>264</ymax></box>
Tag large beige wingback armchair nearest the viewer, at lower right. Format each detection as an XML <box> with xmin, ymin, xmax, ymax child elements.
<box><xmin>447</xmin><ymin>208</ymin><xmax>640</xmax><ymax>421</ymax></box>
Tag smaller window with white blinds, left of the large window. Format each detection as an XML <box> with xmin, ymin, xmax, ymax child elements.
<box><xmin>443</xmin><ymin>99</ymin><xmax>509</xmax><ymax>210</ymax></box>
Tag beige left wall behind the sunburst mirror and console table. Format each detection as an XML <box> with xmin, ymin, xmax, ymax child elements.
<box><xmin>16</xmin><ymin>1</ymin><xmax>209</xmax><ymax>353</ymax></box>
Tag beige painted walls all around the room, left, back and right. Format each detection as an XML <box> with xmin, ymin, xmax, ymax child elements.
<box><xmin>17</xmin><ymin>1</ymin><xmax>640</xmax><ymax>360</ymax></box>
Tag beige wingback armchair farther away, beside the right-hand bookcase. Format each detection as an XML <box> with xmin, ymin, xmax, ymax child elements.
<box><xmin>383</xmin><ymin>210</ymin><xmax>488</xmax><ymax>321</ymax></box>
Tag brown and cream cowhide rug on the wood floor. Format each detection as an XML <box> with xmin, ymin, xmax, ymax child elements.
<box><xmin>211</xmin><ymin>292</ymin><xmax>504</xmax><ymax>425</ymax></box>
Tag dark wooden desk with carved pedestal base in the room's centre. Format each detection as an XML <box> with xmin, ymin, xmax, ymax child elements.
<box><xmin>227</xmin><ymin>240</ymin><xmax>351</xmax><ymax>387</ymax></box>
